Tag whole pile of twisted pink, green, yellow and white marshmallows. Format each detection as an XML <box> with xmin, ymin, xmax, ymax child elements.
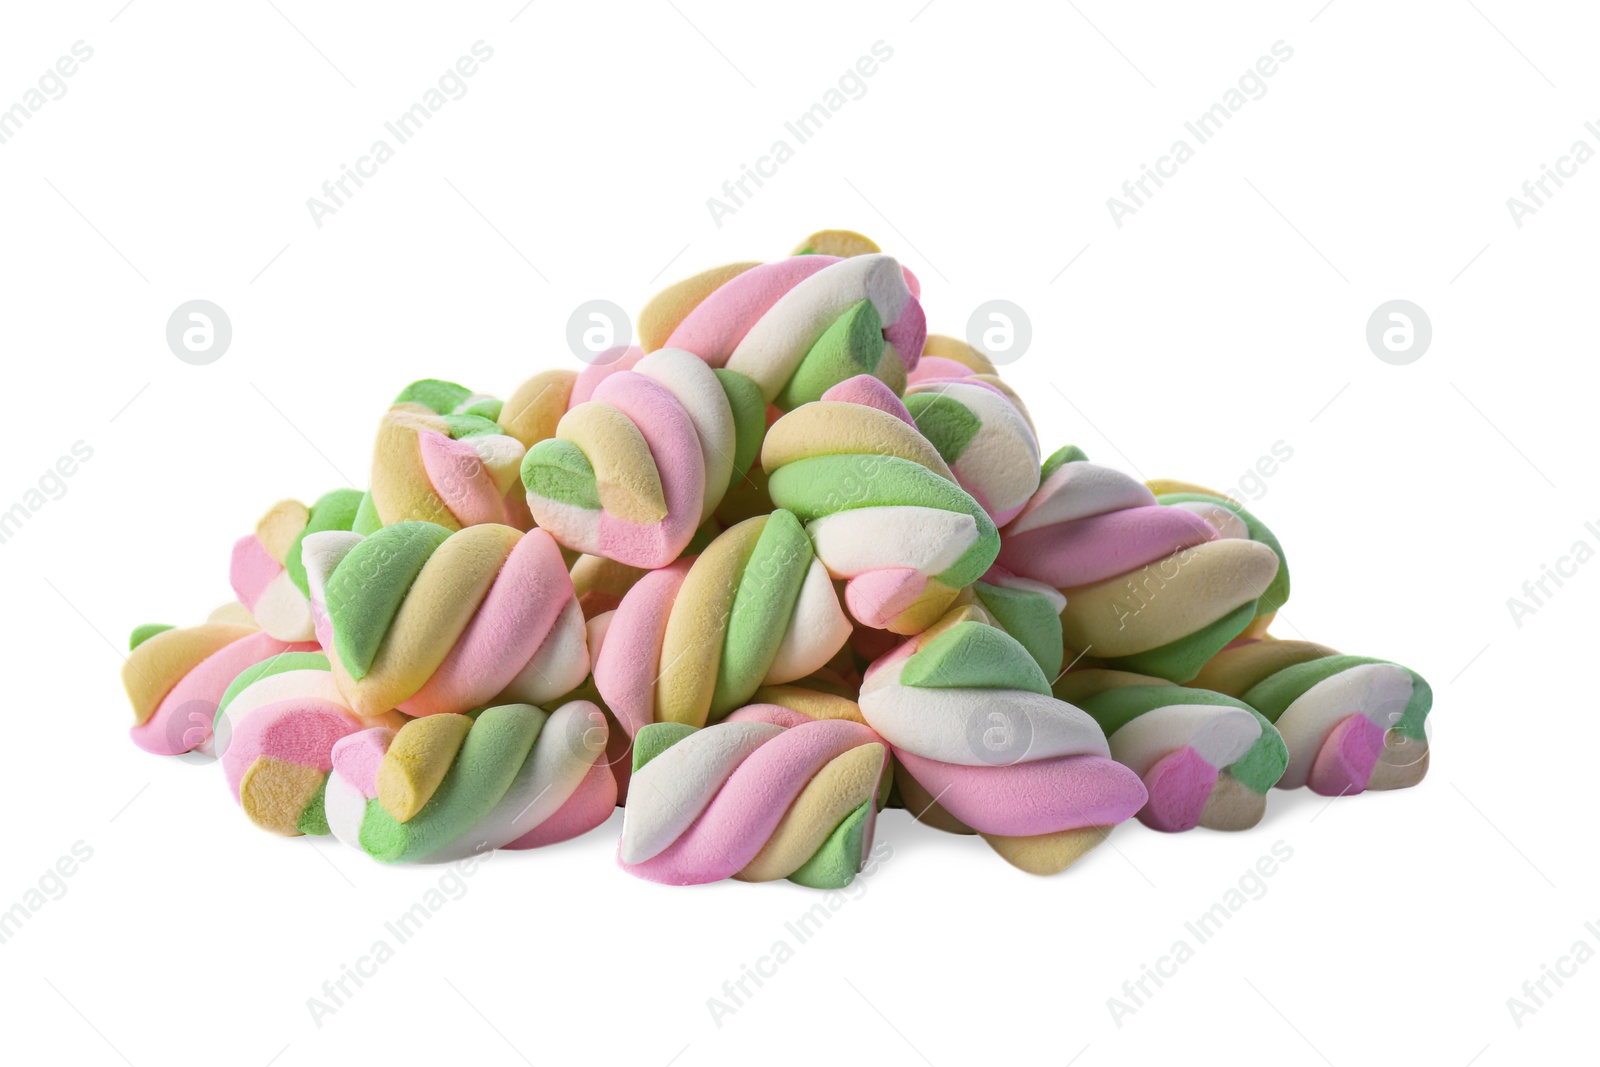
<box><xmin>123</xmin><ymin>230</ymin><xmax>1432</xmax><ymax>888</ymax></box>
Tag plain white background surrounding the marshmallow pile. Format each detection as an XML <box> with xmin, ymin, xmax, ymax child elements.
<box><xmin>0</xmin><ymin>0</ymin><xmax>1600</xmax><ymax>1067</ymax></box>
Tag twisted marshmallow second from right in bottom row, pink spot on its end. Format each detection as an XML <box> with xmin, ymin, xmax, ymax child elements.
<box><xmin>1053</xmin><ymin>669</ymin><xmax>1288</xmax><ymax>832</ymax></box>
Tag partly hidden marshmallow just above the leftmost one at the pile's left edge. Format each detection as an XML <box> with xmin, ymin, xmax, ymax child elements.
<box><xmin>229</xmin><ymin>490</ymin><xmax>362</xmax><ymax>641</ymax></box>
